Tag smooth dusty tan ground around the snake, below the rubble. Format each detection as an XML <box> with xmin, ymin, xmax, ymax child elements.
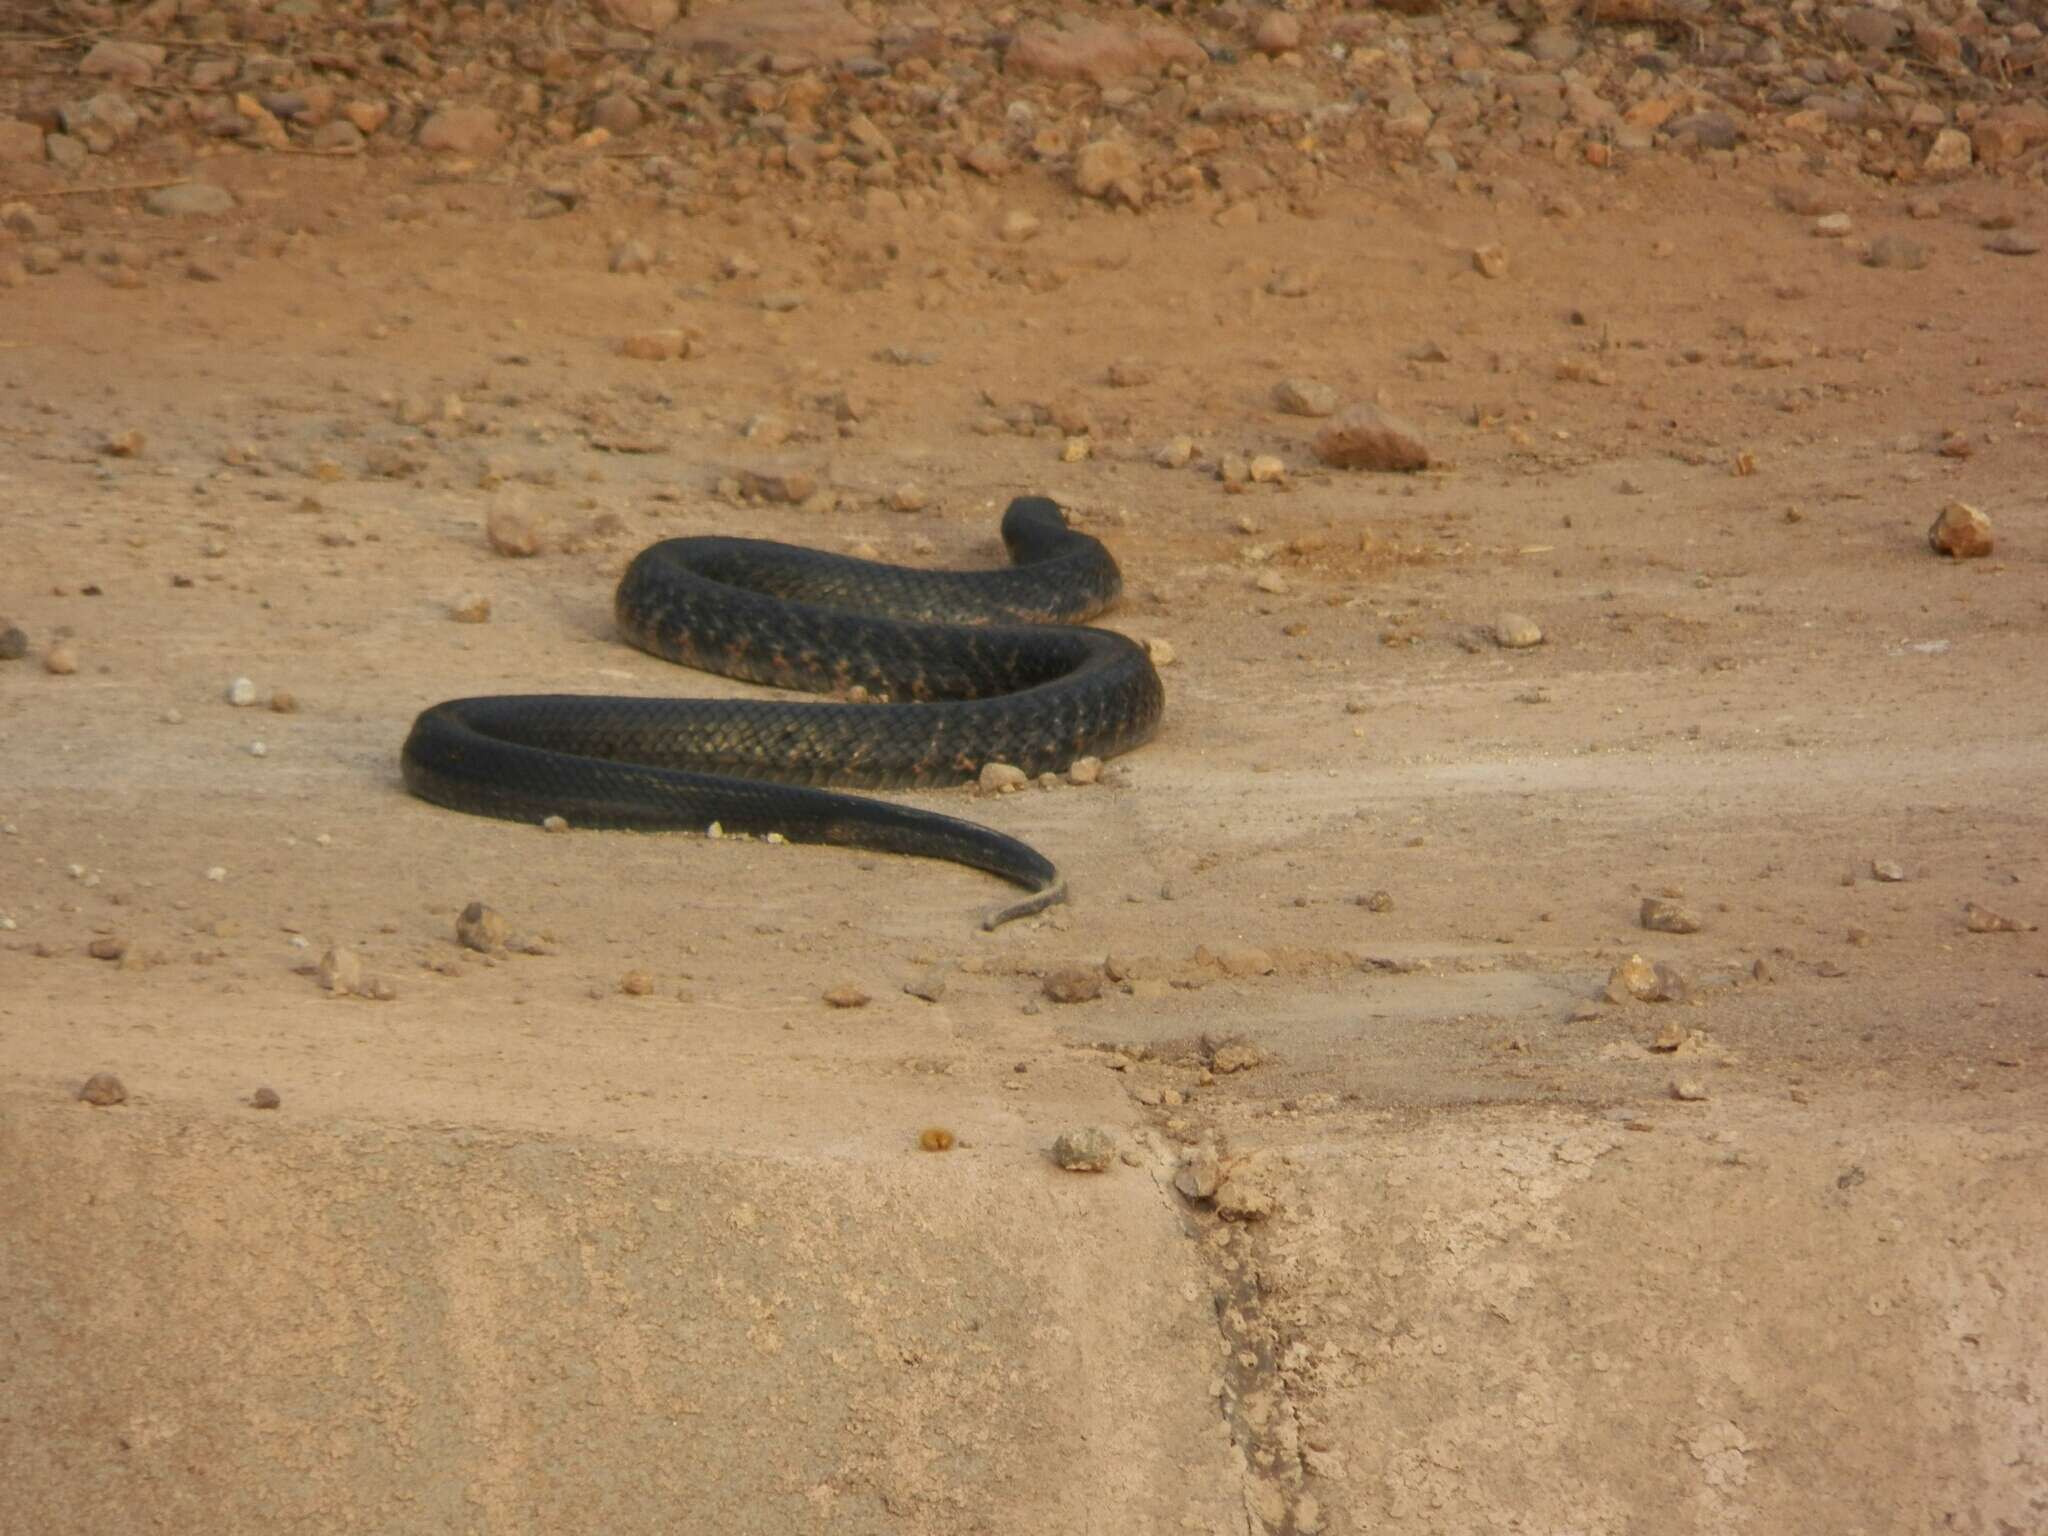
<box><xmin>0</xmin><ymin>0</ymin><xmax>2048</xmax><ymax>1532</ymax></box>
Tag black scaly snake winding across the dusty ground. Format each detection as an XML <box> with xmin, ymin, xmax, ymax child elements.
<box><xmin>399</xmin><ymin>498</ymin><xmax>1163</xmax><ymax>928</ymax></box>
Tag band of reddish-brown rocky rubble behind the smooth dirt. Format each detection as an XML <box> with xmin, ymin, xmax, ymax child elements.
<box><xmin>0</xmin><ymin>0</ymin><xmax>2048</xmax><ymax>259</ymax></box>
